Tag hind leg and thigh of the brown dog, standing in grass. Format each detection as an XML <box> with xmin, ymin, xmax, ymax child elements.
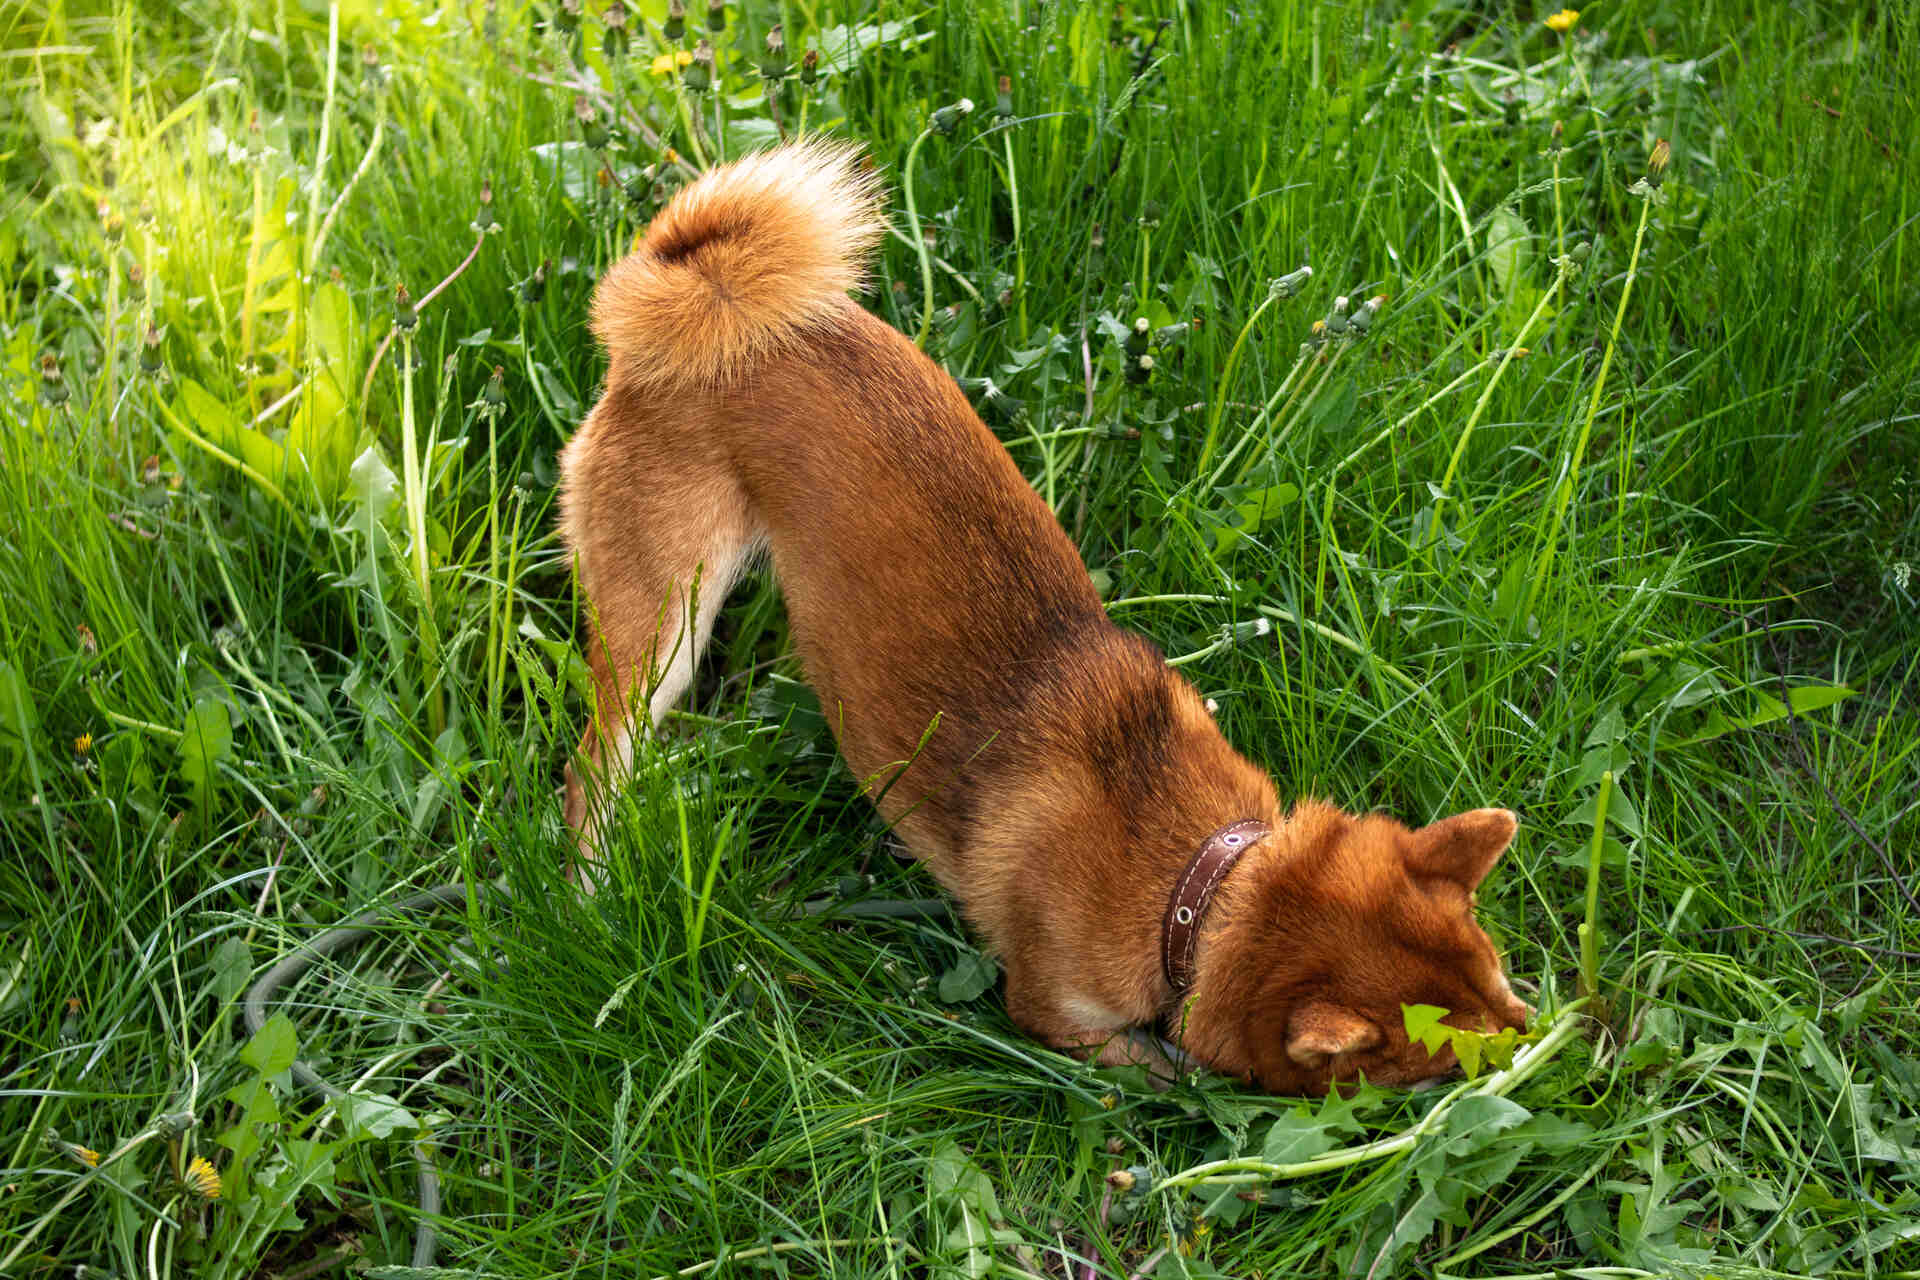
<box><xmin>563</xmin><ymin>430</ymin><xmax>762</xmax><ymax>875</ymax></box>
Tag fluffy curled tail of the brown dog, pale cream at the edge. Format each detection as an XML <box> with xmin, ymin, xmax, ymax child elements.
<box><xmin>593</xmin><ymin>142</ymin><xmax>885</xmax><ymax>390</ymax></box>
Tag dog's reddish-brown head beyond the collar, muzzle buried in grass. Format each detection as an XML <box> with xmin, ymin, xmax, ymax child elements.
<box><xmin>1181</xmin><ymin>804</ymin><xmax>1528</xmax><ymax>1094</ymax></box>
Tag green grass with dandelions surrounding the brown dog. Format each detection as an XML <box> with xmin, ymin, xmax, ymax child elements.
<box><xmin>0</xmin><ymin>0</ymin><xmax>1920</xmax><ymax>1276</ymax></box>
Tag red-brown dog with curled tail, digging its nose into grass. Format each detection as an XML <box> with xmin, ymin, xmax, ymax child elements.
<box><xmin>563</xmin><ymin>144</ymin><xmax>1526</xmax><ymax>1094</ymax></box>
